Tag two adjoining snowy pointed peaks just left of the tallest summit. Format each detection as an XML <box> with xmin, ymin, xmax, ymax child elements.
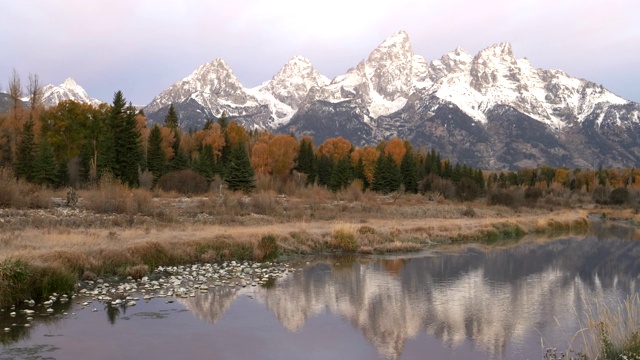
<box><xmin>145</xmin><ymin>56</ymin><xmax>329</xmax><ymax>129</ymax></box>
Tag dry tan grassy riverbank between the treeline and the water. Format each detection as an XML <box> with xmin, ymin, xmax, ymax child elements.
<box><xmin>0</xmin><ymin>191</ymin><xmax>634</xmax><ymax>306</ymax></box>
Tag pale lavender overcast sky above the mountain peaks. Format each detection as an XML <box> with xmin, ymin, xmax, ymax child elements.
<box><xmin>0</xmin><ymin>0</ymin><xmax>640</xmax><ymax>105</ymax></box>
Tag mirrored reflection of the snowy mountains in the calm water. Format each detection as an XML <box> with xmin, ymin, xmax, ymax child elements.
<box><xmin>180</xmin><ymin>237</ymin><xmax>640</xmax><ymax>359</ymax></box>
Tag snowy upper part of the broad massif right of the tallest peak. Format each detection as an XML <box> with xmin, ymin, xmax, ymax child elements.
<box><xmin>431</xmin><ymin>43</ymin><xmax>627</xmax><ymax>130</ymax></box>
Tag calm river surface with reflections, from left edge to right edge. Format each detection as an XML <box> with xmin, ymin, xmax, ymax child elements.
<box><xmin>0</xmin><ymin>229</ymin><xmax>640</xmax><ymax>359</ymax></box>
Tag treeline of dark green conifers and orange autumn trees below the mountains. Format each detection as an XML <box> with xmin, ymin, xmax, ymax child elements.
<box><xmin>0</xmin><ymin>74</ymin><xmax>640</xmax><ymax>203</ymax></box>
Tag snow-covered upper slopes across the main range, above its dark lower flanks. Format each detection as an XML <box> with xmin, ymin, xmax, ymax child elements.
<box><xmin>145</xmin><ymin>31</ymin><xmax>628</xmax><ymax>139</ymax></box>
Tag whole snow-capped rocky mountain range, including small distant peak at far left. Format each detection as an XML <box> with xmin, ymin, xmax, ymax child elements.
<box><xmin>16</xmin><ymin>31</ymin><xmax>640</xmax><ymax>169</ymax></box>
